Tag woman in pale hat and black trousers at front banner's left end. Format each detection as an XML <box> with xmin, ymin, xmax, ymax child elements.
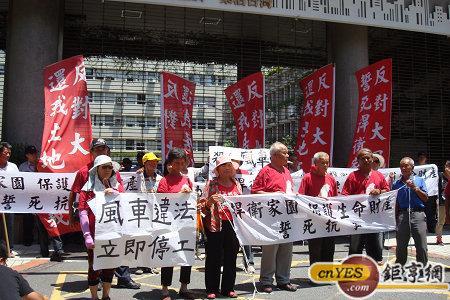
<box><xmin>202</xmin><ymin>155</ymin><xmax>242</xmax><ymax>299</ymax></box>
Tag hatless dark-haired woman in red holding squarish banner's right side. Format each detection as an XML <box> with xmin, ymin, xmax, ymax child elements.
<box><xmin>157</xmin><ymin>148</ymin><xmax>192</xmax><ymax>300</ymax></box>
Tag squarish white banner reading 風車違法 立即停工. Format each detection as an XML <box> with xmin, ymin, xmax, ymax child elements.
<box><xmin>89</xmin><ymin>193</ymin><xmax>197</xmax><ymax>270</ymax></box>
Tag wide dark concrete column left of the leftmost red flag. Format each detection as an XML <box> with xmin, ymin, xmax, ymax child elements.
<box><xmin>2</xmin><ymin>0</ymin><xmax>64</xmax><ymax>148</ymax></box>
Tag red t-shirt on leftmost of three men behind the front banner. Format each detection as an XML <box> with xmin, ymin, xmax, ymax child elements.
<box><xmin>252</xmin><ymin>164</ymin><xmax>294</xmax><ymax>194</ymax></box>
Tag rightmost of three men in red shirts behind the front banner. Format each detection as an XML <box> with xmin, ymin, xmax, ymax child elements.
<box><xmin>342</xmin><ymin>148</ymin><xmax>389</xmax><ymax>264</ymax></box>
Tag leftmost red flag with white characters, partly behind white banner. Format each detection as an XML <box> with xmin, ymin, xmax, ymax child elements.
<box><xmin>38</xmin><ymin>55</ymin><xmax>92</xmax><ymax>236</ymax></box>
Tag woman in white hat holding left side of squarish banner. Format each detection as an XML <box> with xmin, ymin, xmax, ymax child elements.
<box><xmin>78</xmin><ymin>155</ymin><xmax>124</xmax><ymax>299</ymax></box>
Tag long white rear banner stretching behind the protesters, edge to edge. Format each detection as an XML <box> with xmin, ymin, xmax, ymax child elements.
<box><xmin>0</xmin><ymin>165</ymin><xmax>439</xmax><ymax>214</ymax></box>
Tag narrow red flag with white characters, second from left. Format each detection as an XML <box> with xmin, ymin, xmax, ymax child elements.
<box><xmin>161</xmin><ymin>72</ymin><xmax>195</xmax><ymax>163</ymax></box>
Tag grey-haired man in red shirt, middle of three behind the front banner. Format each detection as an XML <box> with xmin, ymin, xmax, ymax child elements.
<box><xmin>298</xmin><ymin>152</ymin><xmax>338</xmax><ymax>265</ymax></box>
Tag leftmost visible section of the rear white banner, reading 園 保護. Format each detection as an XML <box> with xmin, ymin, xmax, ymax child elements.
<box><xmin>0</xmin><ymin>172</ymin><xmax>75</xmax><ymax>214</ymax></box>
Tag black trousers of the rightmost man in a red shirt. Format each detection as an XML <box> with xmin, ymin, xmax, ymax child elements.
<box><xmin>348</xmin><ymin>232</ymin><xmax>383</xmax><ymax>261</ymax></box>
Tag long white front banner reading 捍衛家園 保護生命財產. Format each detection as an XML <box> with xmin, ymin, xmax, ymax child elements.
<box><xmin>224</xmin><ymin>191</ymin><xmax>397</xmax><ymax>245</ymax></box>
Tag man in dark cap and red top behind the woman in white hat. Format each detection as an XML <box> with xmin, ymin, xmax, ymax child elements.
<box><xmin>68</xmin><ymin>139</ymin><xmax>141</xmax><ymax>289</ymax></box>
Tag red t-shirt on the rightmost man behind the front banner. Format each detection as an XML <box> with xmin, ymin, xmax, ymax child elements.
<box><xmin>341</xmin><ymin>170</ymin><xmax>389</xmax><ymax>196</ymax></box>
